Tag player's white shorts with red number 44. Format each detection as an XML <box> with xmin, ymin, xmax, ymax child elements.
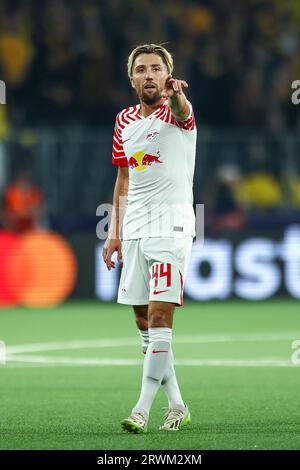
<box><xmin>118</xmin><ymin>237</ymin><xmax>193</xmax><ymax>305</ymax></box>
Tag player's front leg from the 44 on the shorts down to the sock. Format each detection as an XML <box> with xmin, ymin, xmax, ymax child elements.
<box><xmin>130</xmin><ymin>235</ymin><xmax>186</xmax><ymax>414</ymax></box>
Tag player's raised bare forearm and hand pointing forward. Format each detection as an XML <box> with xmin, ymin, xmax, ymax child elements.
<box><xmin>163</xmin><ymin>75</ymin><xmax>190</xmax><ymax>121</ymax></box>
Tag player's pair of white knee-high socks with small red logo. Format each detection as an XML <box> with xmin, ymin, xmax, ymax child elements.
<box><xmin>133</xmin><ymin>328</ymin><xmax>184</xmax><ymax>415</ymax></box>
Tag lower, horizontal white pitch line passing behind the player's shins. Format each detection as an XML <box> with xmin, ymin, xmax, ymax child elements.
<box><xmin>2</xmin><ymin>355</ymin><xmax>295</xmax><ymax>367</ymax></box>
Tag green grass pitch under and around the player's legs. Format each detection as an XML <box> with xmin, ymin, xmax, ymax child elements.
<box><xmin>0</xmin><ymin>299</ymin><xmax>300</xmax><ymax>450</ymax></box>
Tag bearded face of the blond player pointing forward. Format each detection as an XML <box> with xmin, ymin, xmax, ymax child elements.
<box><xmin>131</xmin><ymin>54</ymin><xmax>168</xmax><ymax>105</ymax></box>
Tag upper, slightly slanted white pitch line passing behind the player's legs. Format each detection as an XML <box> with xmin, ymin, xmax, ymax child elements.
<box><xmin>6</xmin><ymin>331</ymin><xmax>300</xmax><ymax>354</ymax></box>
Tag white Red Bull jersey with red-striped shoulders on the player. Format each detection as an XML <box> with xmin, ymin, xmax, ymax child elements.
<box><xmin>112</xmin><ymin>100</ymin><xmax>197</xmax><ymax>240</ymax></box>
